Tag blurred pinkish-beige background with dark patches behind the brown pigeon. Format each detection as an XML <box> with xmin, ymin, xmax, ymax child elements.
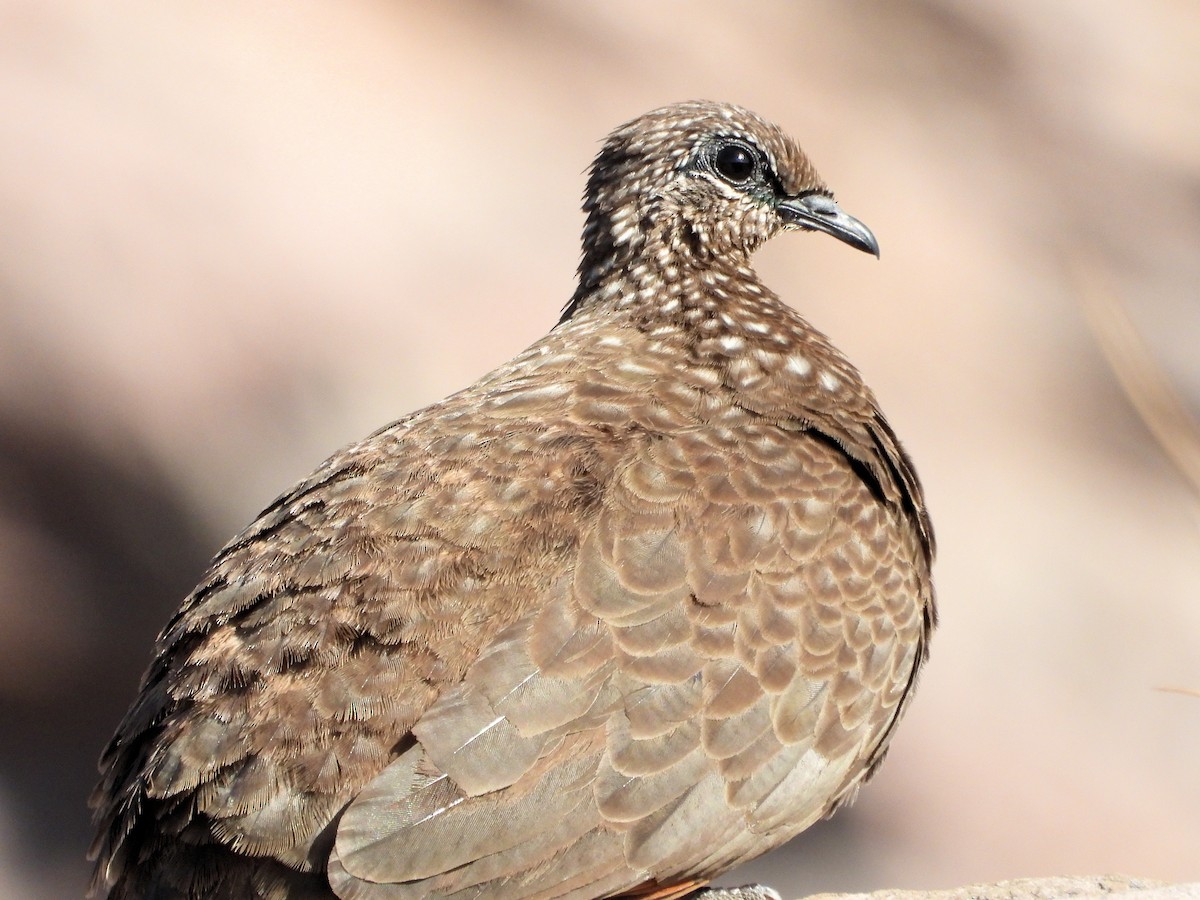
<box><xmin>0</xmin><ymin>0</ymin><xmax>1200</xmax><ymax>900</ymax></box>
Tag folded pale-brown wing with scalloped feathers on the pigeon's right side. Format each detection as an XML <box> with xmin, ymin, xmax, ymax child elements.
<box><xmin>330</xmin><ymin>426</ymin><xmax>925</xmax><ymax>900</ymax></box>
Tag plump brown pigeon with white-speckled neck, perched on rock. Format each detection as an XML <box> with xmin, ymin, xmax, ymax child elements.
<box><xmin>90</xmin><ymin>101</ymin><xmax>936</xmax><ymax>900</ymax></box>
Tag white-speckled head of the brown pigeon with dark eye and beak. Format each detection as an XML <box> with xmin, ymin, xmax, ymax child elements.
<box><xmin>580</xmin><ymin>101</ymin><xmax>880</xmax><ymax>286</ymax></box>
